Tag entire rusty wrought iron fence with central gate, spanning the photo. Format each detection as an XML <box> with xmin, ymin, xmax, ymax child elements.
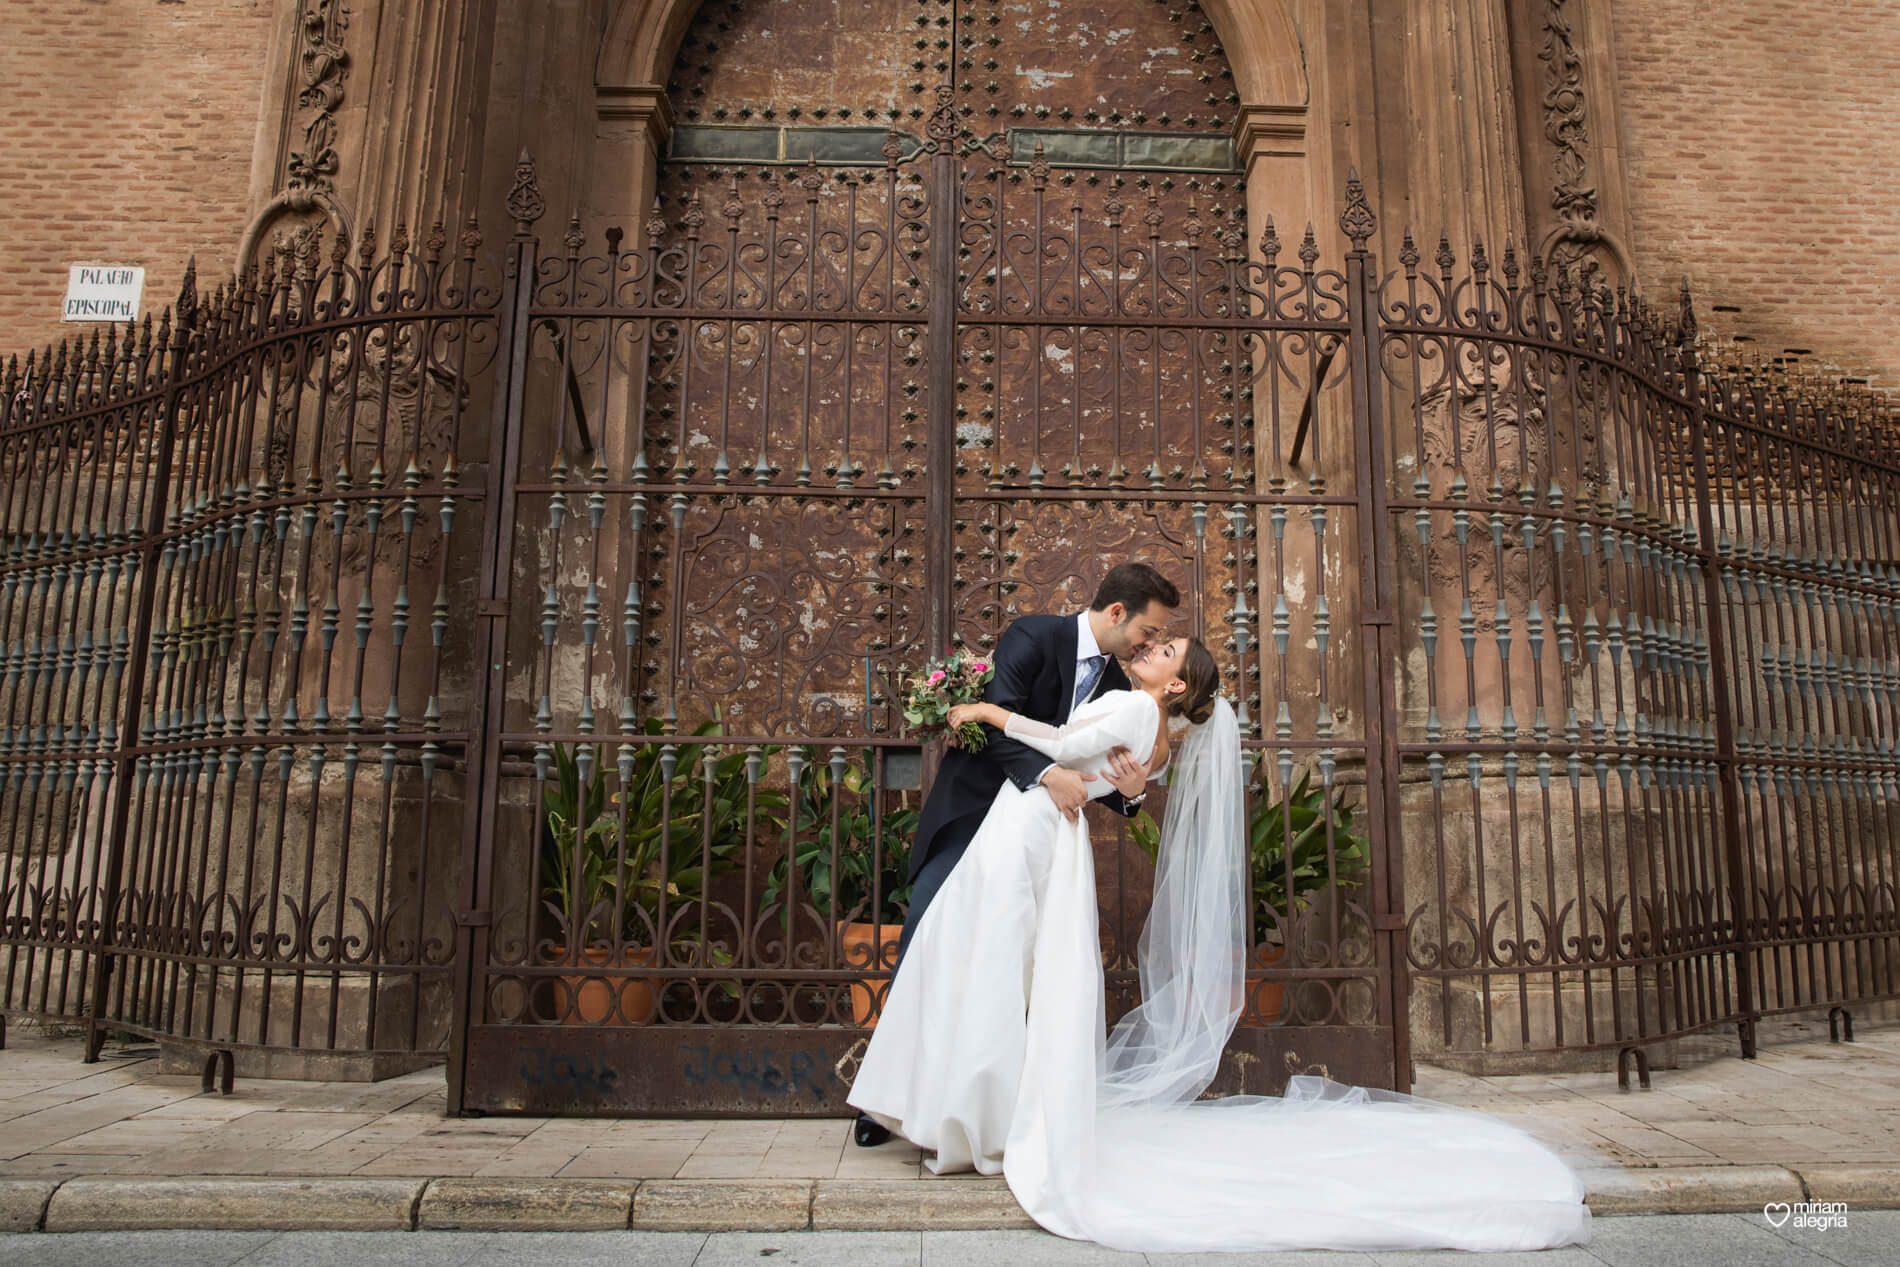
<box><xmin>0</xmin><ymin>153</ymin><xmax>1900</xmax><ymax>1113</ymax></box>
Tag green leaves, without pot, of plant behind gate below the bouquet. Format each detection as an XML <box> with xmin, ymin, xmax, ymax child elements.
<box><xmin>758</xmin><ymin>747</ymin><xmax>920</xmax><ymax>923</ymax></box>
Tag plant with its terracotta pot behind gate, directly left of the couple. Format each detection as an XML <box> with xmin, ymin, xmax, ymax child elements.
<box><xmin>760</xmin><ymin>747</ymin><xmax>918</xmax><ymax>1030</ymax></box>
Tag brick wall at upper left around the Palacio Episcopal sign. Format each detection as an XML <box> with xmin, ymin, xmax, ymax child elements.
<box><xmin>0</xmin><ymin>0</ymin><xmax>274</xmax><ymax>355</ymax></box>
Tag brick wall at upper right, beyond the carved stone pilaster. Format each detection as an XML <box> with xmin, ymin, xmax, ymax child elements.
<box><xmin>1613</xmin><ymin>0</ymin><xmax>1900</xmax><ymax>388</ymax></box>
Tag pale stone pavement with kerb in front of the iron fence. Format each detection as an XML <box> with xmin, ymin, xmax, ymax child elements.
<box><xmin>0</xmin><ymin>1020</ymin><xmax>1900</xmax><ymax>1231</ymax></box>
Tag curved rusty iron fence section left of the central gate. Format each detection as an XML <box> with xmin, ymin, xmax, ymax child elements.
<box><xmin>0</xmin><ymin>226</ymin><xmax>500</xmax><ymax>1071</ymax></box>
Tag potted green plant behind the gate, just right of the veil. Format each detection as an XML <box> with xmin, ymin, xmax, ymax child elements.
<box><xmin>1129</xmin><ymin>771</ymin><xmax>1370</xmax><ymax>1024</ymax></box>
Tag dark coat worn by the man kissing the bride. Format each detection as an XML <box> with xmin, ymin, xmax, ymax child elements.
<box><xmin>910</xmin><ymin>612</ymin><xmax>1136</xmax><ymax>878</ymax></box>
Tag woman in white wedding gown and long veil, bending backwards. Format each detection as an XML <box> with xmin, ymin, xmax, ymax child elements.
<box><xmin>849</xmin><ymin>638</ymin><xmax>1590</xmax><ymax>1252</ymax></box>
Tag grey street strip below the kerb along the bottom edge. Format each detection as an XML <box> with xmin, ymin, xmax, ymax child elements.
<box><xmin>0</xmin><ymin>1210</ymin><xmax>1900</xmax><ymax>1267</ymax></box>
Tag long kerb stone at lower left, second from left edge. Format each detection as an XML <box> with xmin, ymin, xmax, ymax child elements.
<box><xmin>46</xmin><ymin>1178</ymin><xmax>426</xmax><ymax>1231</ymax></box>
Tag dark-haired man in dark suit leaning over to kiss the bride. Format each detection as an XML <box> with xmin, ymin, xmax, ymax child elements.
<box><xmin>853</xmin><ymin>562</ymin><xmax>1182</xmax><ymax>1147</ymax></box>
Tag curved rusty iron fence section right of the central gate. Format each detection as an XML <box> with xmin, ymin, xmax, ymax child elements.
<box><xmin>1379</xmin><ymin>239</ymin><xmax>1900</xmax><ymax>1083</ymax></box>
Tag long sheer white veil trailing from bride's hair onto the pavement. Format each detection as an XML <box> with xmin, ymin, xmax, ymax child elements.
<box><xmin>1056</xmin><ymin>699</ymin><xmax>1590</xmax><ymax>1252</ymax></box>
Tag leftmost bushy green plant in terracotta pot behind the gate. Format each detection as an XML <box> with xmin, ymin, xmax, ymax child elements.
<box><xmin>542</xmin><ymin>718</ymin><xmax>787</xmax><ymax>1024</ymax></box>
